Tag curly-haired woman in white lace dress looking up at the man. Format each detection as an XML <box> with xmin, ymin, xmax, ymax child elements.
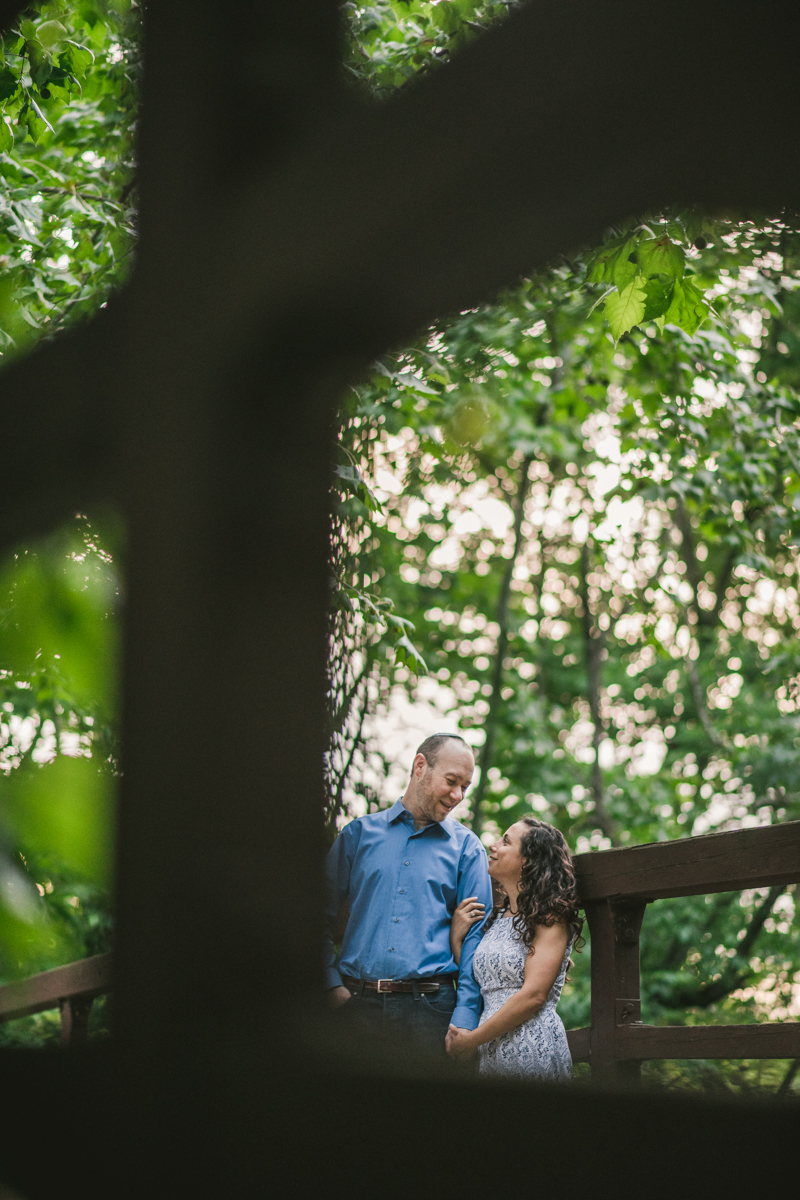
<box><xmin>447</xmin><ymin>817</ymin><xmax>583</xmax><ymax>1079</ymax></box>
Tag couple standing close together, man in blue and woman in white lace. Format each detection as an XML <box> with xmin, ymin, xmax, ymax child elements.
<box><xmin>325</xmin><ymin>733</ymin><xmax>583</xmax><ymax>1079</ymax></box>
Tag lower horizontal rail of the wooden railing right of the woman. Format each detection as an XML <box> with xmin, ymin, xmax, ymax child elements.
<box><xmin>618</xmin><ymin>1021</ymin><xmax>800</xmax><ymax>1062</ymax></box>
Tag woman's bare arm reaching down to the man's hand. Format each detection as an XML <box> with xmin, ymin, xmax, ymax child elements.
<box><xmin>447</xmin><ymin>918</ymin><xmax>571</xmax><ymax>1058</ymax></box>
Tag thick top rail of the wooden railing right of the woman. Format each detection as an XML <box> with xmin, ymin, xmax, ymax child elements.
<box><xmin>573</xmin><ymin>821</ymin><xmax>800</xmax><ymax>901</ymax></box>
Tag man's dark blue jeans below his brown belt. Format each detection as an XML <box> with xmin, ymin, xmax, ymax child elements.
<box><xmin>339</xmin><ymin>983</ymin><xmax>456</xmax><ymax>1058</ymax></box>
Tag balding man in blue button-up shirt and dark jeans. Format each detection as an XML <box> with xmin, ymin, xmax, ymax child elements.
<box><xmin>325</xmin><ymin>733</ymin><xmax>492</xmax><ymax>1055</ymax></box>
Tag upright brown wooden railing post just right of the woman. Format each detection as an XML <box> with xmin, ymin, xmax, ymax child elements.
<box><xmin>585</xmin><ymin>899</ymin><xmax>648</xmax><ymax>1086</ymax></box>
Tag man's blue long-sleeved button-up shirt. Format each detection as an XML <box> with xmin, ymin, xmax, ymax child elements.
<box><xmin>325</xmin><ymin>800</ymin><xmax>492</xmax><ymax>1030</ymax></box>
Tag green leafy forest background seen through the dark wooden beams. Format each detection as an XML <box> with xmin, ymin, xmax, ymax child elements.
<box><xmin>0</xmin><ymin>0</ymin><xmax>800</xmax><ymax>1092</ymax></box>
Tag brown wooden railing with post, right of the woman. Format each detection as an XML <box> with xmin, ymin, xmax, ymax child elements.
<box><xmin>567</xmin><ymin>821</ymin><xmax>800</xmax><ymax>1084</ymax></box>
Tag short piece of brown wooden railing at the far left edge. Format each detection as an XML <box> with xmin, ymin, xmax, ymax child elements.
<box><xmin>0</xmin><ymin>954</ymin><xmax>113</xmax><ymax>1046</ymax></box>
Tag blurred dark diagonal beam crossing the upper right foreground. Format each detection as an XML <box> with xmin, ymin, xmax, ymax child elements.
<box><xmin>206</xmin><ymin>0</ymin><xmax>800</xmax><ymax>374</ymax></box>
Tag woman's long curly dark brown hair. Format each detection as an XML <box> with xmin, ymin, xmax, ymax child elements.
<box><xmin>486</xmin><ymin>817</ymin><xmax>584</xmax><ymax>950</ymax></box>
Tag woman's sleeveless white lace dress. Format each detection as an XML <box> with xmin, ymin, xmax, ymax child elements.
<box><xmin>473</xmin><ymin>917</ymin><xmax>572</xmax><ymax>1080</ymax></box>
